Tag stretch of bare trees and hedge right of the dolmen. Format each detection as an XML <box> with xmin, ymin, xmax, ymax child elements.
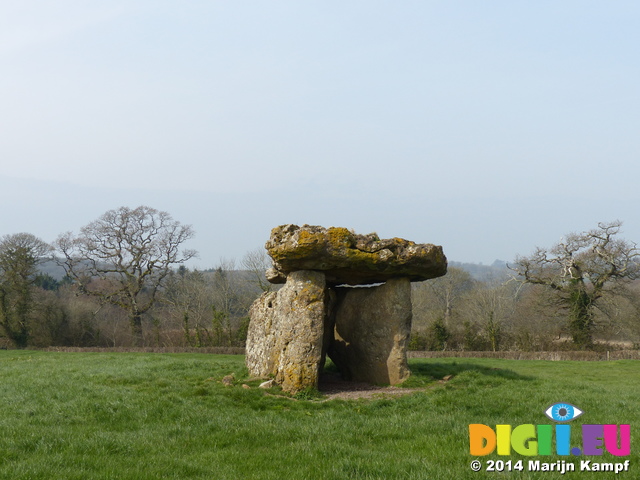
<box><xmin>411</xmin><ymin>221</ymin><xmax>640</xmax><ymax>351</ymax></box>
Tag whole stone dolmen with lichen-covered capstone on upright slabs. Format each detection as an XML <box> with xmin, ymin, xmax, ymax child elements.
<box><xmin>246</xmin><ymin>225</ymin><xmax>447</xmax><ymax>393</ymax></box>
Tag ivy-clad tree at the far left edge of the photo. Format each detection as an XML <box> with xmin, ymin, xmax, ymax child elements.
<box><xmin>0</xmin><ymin>233</ymin><xmax>51</xmax><ymax>348</ymax></box>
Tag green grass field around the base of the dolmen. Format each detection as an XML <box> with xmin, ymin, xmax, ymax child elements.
<box><xmin>0</xmin><ymin>351</ymin><xmax>640</xmax><ymax>480</ymax></box>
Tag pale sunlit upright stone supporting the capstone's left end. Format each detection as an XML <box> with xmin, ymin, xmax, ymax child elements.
<box><xmin>246</xmin><ymin>270</ymin><xmax>325</xmax><ymax>392</ymax></box>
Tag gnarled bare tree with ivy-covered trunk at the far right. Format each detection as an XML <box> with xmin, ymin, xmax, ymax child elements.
<box><xmin>509</xmin><ymin>221</ymin><xmax>640</xmax><ymax>347</ymax></box>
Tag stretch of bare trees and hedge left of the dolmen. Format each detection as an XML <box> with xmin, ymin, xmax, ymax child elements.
<box><xmin>0</xmin><ymin>206</ymin><xmax>270</xmax><ymax>348</ymax></box>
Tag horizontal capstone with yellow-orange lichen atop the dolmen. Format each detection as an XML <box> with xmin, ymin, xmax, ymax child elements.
<box><xmin>265</xmin><ymin>225</ymin><xmax>447</xmax><ymax>285</ymax></box>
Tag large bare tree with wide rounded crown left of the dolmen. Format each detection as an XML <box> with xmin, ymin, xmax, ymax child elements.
<box><xmin>56</xmin><ymin>206</ymin><xmax>196</xmax><ymax>345</ymax></box>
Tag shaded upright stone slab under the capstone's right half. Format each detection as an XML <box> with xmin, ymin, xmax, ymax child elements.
<box><xmin>328</xmin><ymin>278</ymin><xmax>412</xmax><ymax>385</ymax></box>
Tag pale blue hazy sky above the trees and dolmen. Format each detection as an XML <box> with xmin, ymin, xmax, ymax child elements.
<box><xmin>0</xmin><ymin>0</ymin><xmax>640</xmax><ymax>268</ymax></box>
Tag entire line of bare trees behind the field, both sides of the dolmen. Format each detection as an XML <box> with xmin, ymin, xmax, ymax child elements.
<box><xmin>0</xmin><ymin>206</ymin><xmax>640</xmax><ymax>351</ymax></box>
